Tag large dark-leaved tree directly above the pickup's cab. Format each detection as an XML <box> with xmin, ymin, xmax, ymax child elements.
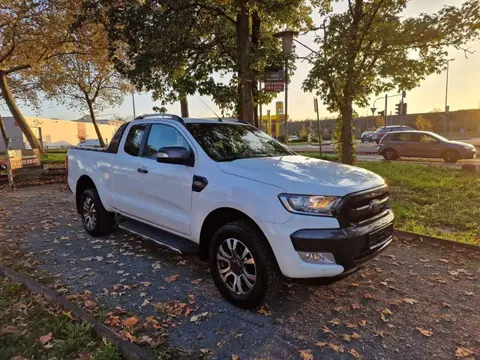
<box><xmin>87</xmin><ymin>0</ymin><xmax>311</xmax><ymax>123</ymax></box>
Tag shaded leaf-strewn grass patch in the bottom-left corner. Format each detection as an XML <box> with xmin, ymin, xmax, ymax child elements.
<box><xmin>0</xmin><ymin>278</ymin><xmax>121</xmax><ymax>360</ymax></box>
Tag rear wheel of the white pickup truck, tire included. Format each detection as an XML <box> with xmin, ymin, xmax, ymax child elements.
<box><xmin>80</xmin><ymin>188</ymin><xmax>115</xmax><ymax>236</ymax></box>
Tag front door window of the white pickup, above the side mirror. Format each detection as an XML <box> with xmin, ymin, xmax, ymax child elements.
<box><xmin>144</xmin><ymin>124</ymin><xmax>191</xmax><ymax>158</ymax></box>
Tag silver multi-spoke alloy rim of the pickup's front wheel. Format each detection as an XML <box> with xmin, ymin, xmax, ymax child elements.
<box><xmin>217</xmin><ymin>238</ymin><xmax>257</xmax><ymax>295</ymax></box>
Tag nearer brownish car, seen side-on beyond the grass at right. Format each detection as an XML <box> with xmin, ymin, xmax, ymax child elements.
<box><xmin>377</xmin><ymin>131</ymin><xmax>476</xmax><ymax>163</ymax></box>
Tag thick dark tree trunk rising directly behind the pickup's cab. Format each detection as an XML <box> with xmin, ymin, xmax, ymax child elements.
<box><xmin>235</xmin><ymin>6</ymin><xmax>255</xmax><ymax>125</ymax></box>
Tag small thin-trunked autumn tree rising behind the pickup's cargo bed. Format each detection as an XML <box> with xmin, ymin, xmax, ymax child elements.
<box><xmin>41</xmin><ymin>24</ymin><xmax>131</xmax><ymax>147</ymax></box>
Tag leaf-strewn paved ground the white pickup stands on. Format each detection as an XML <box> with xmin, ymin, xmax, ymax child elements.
<box><xmin>0</xmin><ymin>185</ymin><xmax>480</xmax><ymax>359</ymax></box>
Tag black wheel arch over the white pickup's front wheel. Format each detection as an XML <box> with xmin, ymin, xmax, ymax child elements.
<box><xmin>200</xmin><ymin>207</ymin><xmax>276</xmax><ymax>261</ymax></box>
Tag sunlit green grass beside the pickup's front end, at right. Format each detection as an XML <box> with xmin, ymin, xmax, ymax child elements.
<box><xmin>359</xmin><ymin>162</ymin><xmax>480</xmax><ymax>245</ymax></box>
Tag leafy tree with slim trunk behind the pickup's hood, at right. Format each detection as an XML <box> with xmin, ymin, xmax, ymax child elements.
<box><xmin>303</xmin><ymin>0</ymin><xmax>480</xmax><ymax>164</ymax></box>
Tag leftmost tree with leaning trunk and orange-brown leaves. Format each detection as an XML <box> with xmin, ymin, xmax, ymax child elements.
<box><xmin>0</xmin><ymin>0</ymin><xmax>80</xmax><ymax>149</ymax></box>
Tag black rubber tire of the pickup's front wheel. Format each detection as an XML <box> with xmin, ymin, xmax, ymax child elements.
<box><xmin>209</xmin><ymin>221</ymin><xmax>282</xmax><ymax>309</ymax></box>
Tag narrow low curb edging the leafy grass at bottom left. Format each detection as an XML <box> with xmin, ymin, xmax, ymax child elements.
<box><xmin>0</xmin><ymin>265</ymin><xmax>151</xmax><ymax>360</ymax></box>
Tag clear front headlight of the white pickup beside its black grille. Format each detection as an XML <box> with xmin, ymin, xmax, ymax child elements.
<box><xmin>278</xmin><ymin>194</ymin><xmax>341</xmax><ymax>216</ymax></box>
